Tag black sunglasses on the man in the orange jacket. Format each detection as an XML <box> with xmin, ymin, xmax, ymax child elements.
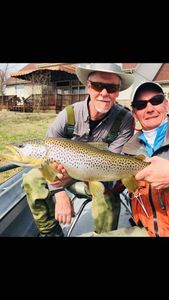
<box><xmin>131</xmin><ymin>94</ymin><xmax>165</xmax><ymax>110</ymax></box>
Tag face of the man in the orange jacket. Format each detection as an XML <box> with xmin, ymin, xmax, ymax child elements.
<box><xmin>132</xmin><ymin>91</ymin><xmax>169</xmax><ymax>130</ymax></box>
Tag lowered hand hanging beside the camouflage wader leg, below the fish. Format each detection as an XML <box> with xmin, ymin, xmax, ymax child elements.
<box><xmin>55</xmin><ymin>191</ymin><xmax>75</xmax><ymax>224</ymax></box>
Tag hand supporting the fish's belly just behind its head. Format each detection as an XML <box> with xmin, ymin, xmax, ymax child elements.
<box><xmin>50</xmin><ymin>162</ymin><xmax>72</xmax><ymax>188</ymax></box>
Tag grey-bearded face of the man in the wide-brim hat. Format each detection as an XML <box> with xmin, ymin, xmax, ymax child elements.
<box><xmin>87</xmin><ymin>72</ymin><xmax>121</xmax><ymax>114</ymax></box>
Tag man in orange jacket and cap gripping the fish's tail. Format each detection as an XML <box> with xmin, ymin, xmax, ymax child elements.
<box><xmin>99</xmin><ymin>81</ymin><xmax>169</xmax><ymax>237</ymax></box>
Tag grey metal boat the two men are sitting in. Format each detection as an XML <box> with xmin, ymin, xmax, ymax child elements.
<box><xmin>0</xmin><ymin>164</ymin><xmax>132</xmax><ymax>237</ymax></box>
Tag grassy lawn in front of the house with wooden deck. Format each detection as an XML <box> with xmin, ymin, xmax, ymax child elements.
<box><xmin>0</xmin><ymin>111</ymin><xmax>56</xmax><ymax>183</ymax></box>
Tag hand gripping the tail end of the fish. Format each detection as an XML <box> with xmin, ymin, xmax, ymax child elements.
<box><xmin>135</xmin><ymin>156</ymin><xmax>169</xmax><ymax>190</ymax></box>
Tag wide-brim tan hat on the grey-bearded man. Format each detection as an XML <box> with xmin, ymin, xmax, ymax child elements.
<box><xmin>76</xmin><ymin>63</ymin><xmax>135</xmax><ymax>91</ymax></box>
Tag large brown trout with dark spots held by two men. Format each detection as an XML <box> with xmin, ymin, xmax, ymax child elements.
<box><xmin>0</xmin><ymin>138</ymin><xmax>149</xmax><ymax>190</ymax></box>
